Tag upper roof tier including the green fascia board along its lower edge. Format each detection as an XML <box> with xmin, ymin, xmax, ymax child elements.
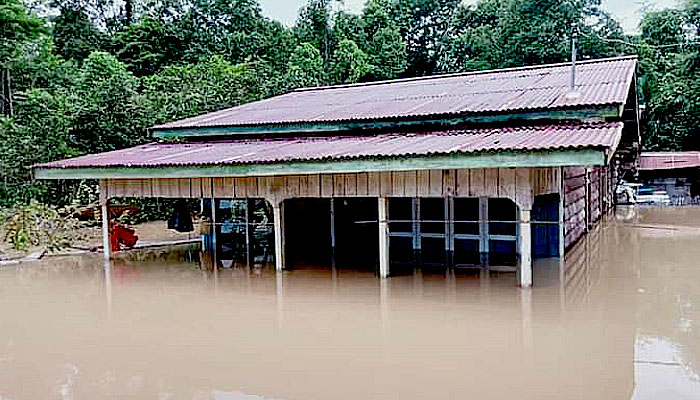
<box><xmin>152</xmin><ymin>57</ymin><xmax>637</xmax><ymax>136</ymax></box>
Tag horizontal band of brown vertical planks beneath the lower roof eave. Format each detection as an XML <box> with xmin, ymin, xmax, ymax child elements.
<box><xmin>104</xmin><ymin>168</ymin><xmax>560</xmax><ymax>207</ymax></box>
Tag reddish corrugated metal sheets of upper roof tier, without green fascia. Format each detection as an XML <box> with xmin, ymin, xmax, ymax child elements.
<box><xmin>153</xmin><ymin>57</ymin><xmax>637</xmax><ymax>130</ymax></box>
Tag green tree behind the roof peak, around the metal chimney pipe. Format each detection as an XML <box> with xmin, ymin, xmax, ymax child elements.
<box><xmin>439</xmin><ymin>0</ymin><xmax>631</xmax><ymax>71</ymax></box>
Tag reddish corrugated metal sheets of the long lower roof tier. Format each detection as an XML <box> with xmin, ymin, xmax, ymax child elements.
<box><xmin>35</xmin><ymin>122</ymin><xmax>623</xmax><ymax>168</ymax></box>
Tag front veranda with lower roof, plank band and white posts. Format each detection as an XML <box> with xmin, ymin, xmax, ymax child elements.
<box><xmin>35</xmin><ymin>123</ymin><xmax>621</xmax><ymax>286</ymax></box>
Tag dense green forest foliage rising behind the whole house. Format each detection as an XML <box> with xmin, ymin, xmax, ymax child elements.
<box><xmin>0</xmin><ymin>0</ymin><xmax>700</xmax><ymax>207</ymax></box>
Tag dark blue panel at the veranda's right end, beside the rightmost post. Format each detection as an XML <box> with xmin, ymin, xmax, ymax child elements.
<box><xmin>532</xmin><ymin>194</ymin><xmax>559</xmax><ymax>257</ymax></box>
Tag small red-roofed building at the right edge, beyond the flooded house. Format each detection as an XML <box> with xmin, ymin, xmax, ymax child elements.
<box><xmin>639</xmin><ymin>151</ymin><xmax>700</xmax><ymax>204</ymax></box>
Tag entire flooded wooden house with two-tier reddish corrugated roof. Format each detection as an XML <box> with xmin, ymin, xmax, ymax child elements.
<box><xmin>34</xmin><ymin>57</ymin><xmax>639</xmax><ymax>286</ymax></box>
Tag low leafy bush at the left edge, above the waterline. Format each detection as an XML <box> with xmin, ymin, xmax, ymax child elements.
<box><xmin>0</xmin><ymin>201</ymin><xmax>89</xmax><ymax>251</ymax></box>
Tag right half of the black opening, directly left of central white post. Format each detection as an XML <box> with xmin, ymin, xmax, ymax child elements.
<box><xmin>333</xmin><ymin>198</ymin><xmax>379</xmax><ymax>270</ymax></box>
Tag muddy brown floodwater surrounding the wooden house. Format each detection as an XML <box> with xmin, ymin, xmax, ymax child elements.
<box><xmin>0</xmin><ymin>208</ymin><xmax>700</xmax><ymax>400</ymax></box>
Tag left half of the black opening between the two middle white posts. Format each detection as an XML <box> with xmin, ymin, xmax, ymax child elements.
<box><xmin>284</xmin><ymin>199</ymin><xmax>332</xmax><ymax>268</ymax></box>
